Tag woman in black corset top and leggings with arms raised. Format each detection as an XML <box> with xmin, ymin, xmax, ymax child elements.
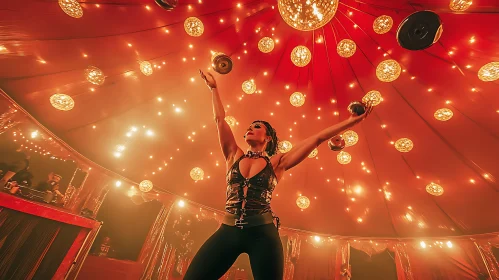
<box><xmin>184</xmin><ymin>70</ymin><xmax>372</xmax><ymax>280</ymax></box>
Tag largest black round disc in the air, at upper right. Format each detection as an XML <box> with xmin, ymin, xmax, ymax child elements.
<box><xmin>397</xmin><ymin>11</ymin><xmax>443</xmax><ymax>51</ymax></box>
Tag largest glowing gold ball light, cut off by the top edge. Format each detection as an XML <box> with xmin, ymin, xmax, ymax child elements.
<box><xmin>277</xmin><ymin>0</ymin><xmax>339</xmax><ymax>31</ymax></box>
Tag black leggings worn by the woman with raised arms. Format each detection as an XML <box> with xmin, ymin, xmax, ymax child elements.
<box><xmin>184</xmin><ymin>224</ymin><xmax>284</xmax><ymax>280</ymax></box>
